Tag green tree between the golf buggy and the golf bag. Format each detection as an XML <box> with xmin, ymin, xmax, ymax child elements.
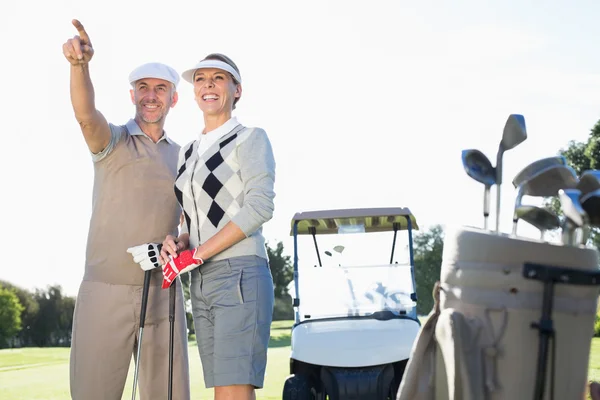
<box><xmin>413</xmin><ymin>225</ymin><xmax>444</xmax><ymax>315</ymax></box>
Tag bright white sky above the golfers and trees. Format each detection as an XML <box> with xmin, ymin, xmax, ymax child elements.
<box><xmin>0</xmin><ymin>0</ymin><xmax>600</xmax><ymax>295</ymax></box>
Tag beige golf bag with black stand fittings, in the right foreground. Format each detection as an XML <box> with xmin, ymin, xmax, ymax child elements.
<box><xmin>397</xmin><ymin>228</ymin><xmax>600</xmax><ymax>400</ymax></box>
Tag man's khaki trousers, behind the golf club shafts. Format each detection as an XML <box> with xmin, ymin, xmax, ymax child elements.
<box><xmin>70</xmin><ymin>279</ymin><xmax>190</xmax><ymax>400</ymax></box>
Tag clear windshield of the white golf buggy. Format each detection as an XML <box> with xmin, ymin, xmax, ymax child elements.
<box><xmin>288</xmin><ymin>231</ymin><xmax>416</xmax><ymax>320</ymax></box>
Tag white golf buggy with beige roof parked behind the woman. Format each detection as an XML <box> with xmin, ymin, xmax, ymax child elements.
<box><xmin>283</xmin><ymin>208</ymin><xmax>420</xmax><ymax>400</ymax></box>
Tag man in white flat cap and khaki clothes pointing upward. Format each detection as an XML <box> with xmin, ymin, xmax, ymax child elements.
<box><xmin>63</xmin><ymin>20</ymin><xmax>190</xmax><ymax>400</ymax></box>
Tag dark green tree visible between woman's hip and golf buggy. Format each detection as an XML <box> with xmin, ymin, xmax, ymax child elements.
<box><xmin>266</xmin><ymin>242</ymin><xmax>294</xmax><ymax>320</ymax></box>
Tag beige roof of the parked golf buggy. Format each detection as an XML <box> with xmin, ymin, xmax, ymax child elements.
<box><xmin>290</xmin><ymin>207</ymin><xmax>419</xmax><ymax>236</ymax></box>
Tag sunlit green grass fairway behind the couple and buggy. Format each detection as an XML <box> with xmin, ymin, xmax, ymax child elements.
<box><xmin>0</xmin><ymin>321</ymin><xmax>600</xmax><ymax>400</ymax></box>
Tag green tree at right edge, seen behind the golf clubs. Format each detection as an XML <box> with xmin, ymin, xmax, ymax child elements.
<box><xmin>545</xmin><ymin>120</ymin><xmax>600</xmax><ymax>248</ymax></box>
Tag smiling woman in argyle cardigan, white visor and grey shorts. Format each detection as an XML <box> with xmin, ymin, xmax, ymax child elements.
<box><xmin>161</xmin><ymin>54</ymin><xmax>275</xmax><ymax>400</ymax></box>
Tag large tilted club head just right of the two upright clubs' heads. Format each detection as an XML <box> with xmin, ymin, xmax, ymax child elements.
<box><xmin>520</xmin><ymin>165</ymin><xmax>578</xmax><ymax>197</ymax></box>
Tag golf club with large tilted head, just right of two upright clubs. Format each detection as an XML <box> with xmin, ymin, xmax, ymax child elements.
<box><xmin>512</xmin><ymin>163</ymin><xmax>578</xmax><ymax>235</ymax></box>
